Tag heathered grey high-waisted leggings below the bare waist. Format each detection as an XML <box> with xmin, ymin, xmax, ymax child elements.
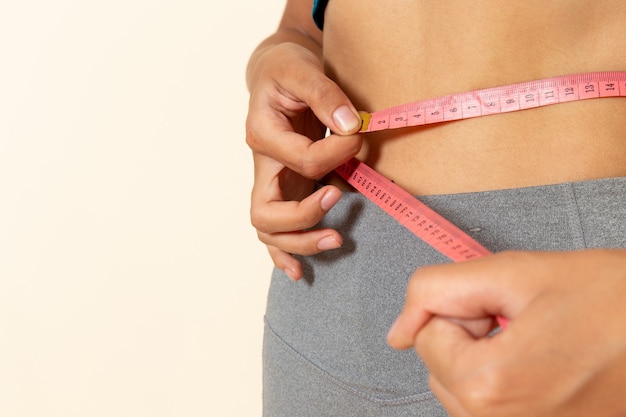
<box><xmin>263</xmin><ymin>177</ymin><xmax>626</xmax><ymax>417</ymax></box>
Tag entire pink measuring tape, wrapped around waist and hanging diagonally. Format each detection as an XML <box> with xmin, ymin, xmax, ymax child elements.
<box><xmin>336</xmin><ymin>72</ymin><xmax>626</xmax><ymax>327</ymax></box>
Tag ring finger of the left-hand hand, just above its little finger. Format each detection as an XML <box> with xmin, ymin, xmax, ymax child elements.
<box><xmin>258</xmin><ymin>229</ymin><xmax>342</xmax><ymax>256</ymax></box>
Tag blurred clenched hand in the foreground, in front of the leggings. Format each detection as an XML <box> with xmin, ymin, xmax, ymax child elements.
<box><xmin>388</xmin><ymin>249</ymin><xmax>626</xmax><ymax>417</ymax></box>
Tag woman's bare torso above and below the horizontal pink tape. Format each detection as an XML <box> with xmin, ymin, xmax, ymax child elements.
<box><xmin>324</xmin><ymin>0</ymin><xmax>626</xmax><ymax>195</ymax></box>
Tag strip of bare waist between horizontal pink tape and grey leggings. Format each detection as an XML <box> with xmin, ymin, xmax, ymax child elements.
<box><xmin>328</xmin><ymin>93</ymin><xmax>626</xmax><ymax>195</ymax></box>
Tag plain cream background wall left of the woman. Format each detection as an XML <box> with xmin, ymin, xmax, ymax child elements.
<box><xmin>0</xmin><ymin>0</ymin><xmax>284</xmax><ymax>417</ymax></box>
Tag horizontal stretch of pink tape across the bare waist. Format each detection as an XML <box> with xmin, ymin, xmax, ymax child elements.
<box><xmin>361</xmin><ymin>71</ymin><xmax>626</xmax><ymax>132</ymax></box>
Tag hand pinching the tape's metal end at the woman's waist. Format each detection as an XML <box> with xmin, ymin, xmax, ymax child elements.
<box><xmin>246</xmin><ymin>42</ymin><xmax>362</xmax><ymax>280</ymax></box>
